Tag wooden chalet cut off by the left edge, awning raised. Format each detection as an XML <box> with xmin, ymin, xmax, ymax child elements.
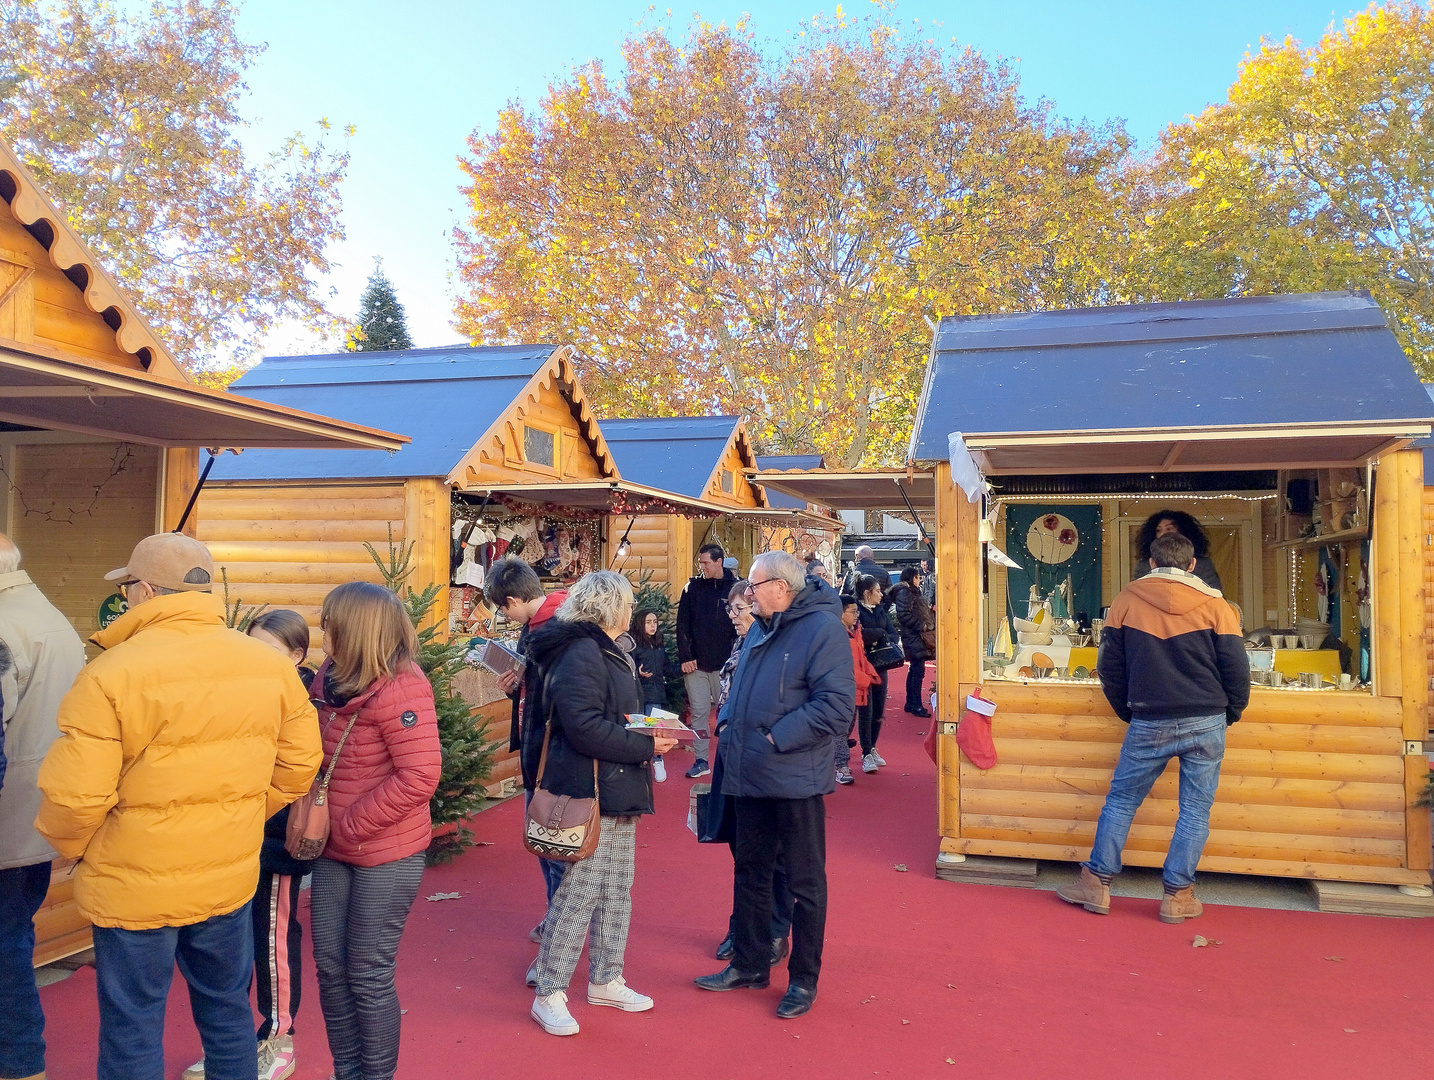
<box><xmin>0</xmin><ymin>136</ymin><xmax>406</xmax><ymax>964</ymax></box>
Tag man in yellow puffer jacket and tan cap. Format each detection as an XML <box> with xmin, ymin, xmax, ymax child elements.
<box><xmin>34</xmin><ymin>534</ymin><xmax>323</xmax><ymax>1080</ymax></box>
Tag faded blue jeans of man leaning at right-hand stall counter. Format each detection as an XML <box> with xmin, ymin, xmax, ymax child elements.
<box><xmin>1086</xmin><ymin>713</ymin><xmax>1225</xmax><ymax>891</ymax></box>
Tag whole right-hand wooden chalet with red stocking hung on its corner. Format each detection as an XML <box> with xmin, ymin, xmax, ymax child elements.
<box><xmin>911</xmin><ymin>293</ymin><xmax>1434</xmax><ymax>892</ymax></box>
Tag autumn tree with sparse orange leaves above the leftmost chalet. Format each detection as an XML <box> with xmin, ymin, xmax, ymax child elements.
<box><xmin>0</xmin><ymin>0</ymin><xmax>348</xmax><ymax>366</ymax></box>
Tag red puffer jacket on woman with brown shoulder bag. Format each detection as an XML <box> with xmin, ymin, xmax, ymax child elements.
<box><xmin>314</xmin><ymin>664</ymin><xmax>443</xmax><ymax>866</ymax></box>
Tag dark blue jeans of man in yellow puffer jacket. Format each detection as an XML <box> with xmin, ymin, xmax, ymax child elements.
<box><xmin>95</xmin><ymin>904</ymin><xmax>258</xmax><ymax>1080</ymax></box>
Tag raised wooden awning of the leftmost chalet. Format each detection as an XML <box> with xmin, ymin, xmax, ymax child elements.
<box><xmin>0</xmin><ymin>343</ymin><xmax>409</xmax><ymax>450</ymax></box>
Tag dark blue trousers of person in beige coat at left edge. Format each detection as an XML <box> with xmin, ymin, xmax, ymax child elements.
<box><xmin>0</xmin><ymin>862</ymin><xmax>50</xmax><ymax>1077</ymax></box>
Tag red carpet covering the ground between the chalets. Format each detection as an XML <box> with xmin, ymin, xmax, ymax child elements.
<box><xmin>42</xmin><ymin>671</ymin><xmax>1434</xmax><ymax>1080</ymax></box>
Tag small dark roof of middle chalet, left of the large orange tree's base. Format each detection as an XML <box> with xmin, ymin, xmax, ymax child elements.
<box><xmin>598</xmin><ymin>416</ymin><xmax>740</xmax><ymax>499</ymax></box>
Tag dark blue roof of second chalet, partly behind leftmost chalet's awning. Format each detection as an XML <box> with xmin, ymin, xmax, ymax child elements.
<box><xmin>214</xmin><ymin>346</ymin><xmax>558</xmax><ymax>480</ymax></box>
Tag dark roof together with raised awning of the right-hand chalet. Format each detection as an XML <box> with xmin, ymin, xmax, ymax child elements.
<box><xmin>911</xmin><ymin>293</ymin><xmax>1434</xmax><ymax>472</ymax></box>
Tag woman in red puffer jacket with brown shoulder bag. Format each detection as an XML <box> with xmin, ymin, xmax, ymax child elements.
<box><xmin>311</xmin><ymin>581</ymin><xmax>442</xmax><ymax>1080</ymax></box>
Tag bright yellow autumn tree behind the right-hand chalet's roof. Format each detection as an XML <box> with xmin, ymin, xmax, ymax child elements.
<box><xmin>1130</xmin><ymin>3</ymin><xmax>1434</xmax><ymax>377</ymax></box>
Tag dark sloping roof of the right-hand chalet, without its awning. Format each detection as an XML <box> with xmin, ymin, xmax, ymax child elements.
<box><xmin>912</xmin><ymin>293</ymin><xmax>1434</xmax><ymax>460</ymax></box>
